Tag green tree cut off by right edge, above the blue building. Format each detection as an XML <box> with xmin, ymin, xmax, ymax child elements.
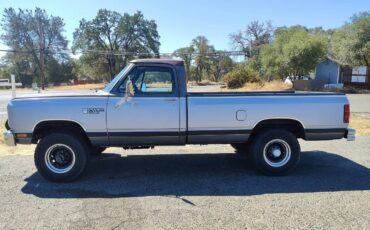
<box><xmin>330</xmin><ymin>11</ymin><xmax>370</xmax><ymax>66</ymax></box>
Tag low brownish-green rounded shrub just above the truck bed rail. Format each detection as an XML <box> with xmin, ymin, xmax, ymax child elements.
<box><xmin>224</xmin><ymin>64</ymin><xmax>260</xmax><ymax>89</ymax></box>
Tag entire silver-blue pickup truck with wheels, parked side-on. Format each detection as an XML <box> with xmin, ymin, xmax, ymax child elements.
<box><xmin>4</xmin><ymin>59</ymin><xmax>355</xmax><ymax>181</ymax></box>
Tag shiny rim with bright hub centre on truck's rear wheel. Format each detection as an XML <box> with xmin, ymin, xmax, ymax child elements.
<box><xmin>263</xmin><ymin>139</ymin><xmax>291</xmax><ymax>168</ymax></box>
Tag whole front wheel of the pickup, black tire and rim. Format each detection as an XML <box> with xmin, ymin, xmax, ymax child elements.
<box><xmin>34</xmin><ymin>133</ymin><xmax>89</xmax><ymax>182</ymax></box>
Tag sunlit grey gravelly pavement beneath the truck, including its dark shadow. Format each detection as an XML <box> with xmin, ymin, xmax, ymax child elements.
<box><xmin>0</xmin><ymin>137</ymin><xmax>370</xmax><ymax>230</ymax></box>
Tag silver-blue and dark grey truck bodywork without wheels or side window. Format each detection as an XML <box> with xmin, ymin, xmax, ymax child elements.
<box><xmin>4</xmin><ymin>60</ymin><xmax>354</xmax><ymax>146</ymax></box>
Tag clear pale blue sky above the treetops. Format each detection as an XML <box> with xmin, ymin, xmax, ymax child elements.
<box><xmin>0</xmin><ymin>0</ymin><xmax>370</xmax><ymax>53</ymax></box>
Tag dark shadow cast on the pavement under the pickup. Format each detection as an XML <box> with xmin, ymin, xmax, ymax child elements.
<box><xmin>22</xmin><ymin>151</ymin><xmax>370</xmax><ymax>198</ymax></box>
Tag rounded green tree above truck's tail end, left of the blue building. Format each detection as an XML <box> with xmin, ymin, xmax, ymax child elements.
<box><xmin>261</xmin><ymin>26</ymin><xmax>328</xmax><ymax>77</ymax></box>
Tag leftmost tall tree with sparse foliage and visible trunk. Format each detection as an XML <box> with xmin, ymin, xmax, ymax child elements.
<box><xmin>1</xmin><ymin>8</ymin><xmax>67</xmax><ymax>89</ymax></box>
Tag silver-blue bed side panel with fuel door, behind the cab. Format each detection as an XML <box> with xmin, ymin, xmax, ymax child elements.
<box><xmin>188</xmin><ymin>94</ymin><xmax>348</xmax><ymax>143</ymax></box>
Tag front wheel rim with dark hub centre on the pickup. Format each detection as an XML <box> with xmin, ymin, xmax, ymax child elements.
<box><xmin>45</xmin><ymin>144</ymin><xmax>76</xmax><ymax>174</ymax></box>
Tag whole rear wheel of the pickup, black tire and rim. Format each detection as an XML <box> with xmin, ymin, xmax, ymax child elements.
<box><xmin>250</xmin><ymin>129</ymin><xmax>301</xmax><ymax>175</ymax></box>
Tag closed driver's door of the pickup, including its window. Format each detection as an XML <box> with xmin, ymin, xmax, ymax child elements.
<box><xmin>107</xmin><ymin>66</ymin><xmax>180</xmax><ymax>146</ymax></box>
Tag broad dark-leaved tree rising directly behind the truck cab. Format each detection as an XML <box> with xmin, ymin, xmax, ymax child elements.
<box><xmin>73</xmin><ymin>9</ymin><xmax>160</xmax><ymax>81</ymax></box>
